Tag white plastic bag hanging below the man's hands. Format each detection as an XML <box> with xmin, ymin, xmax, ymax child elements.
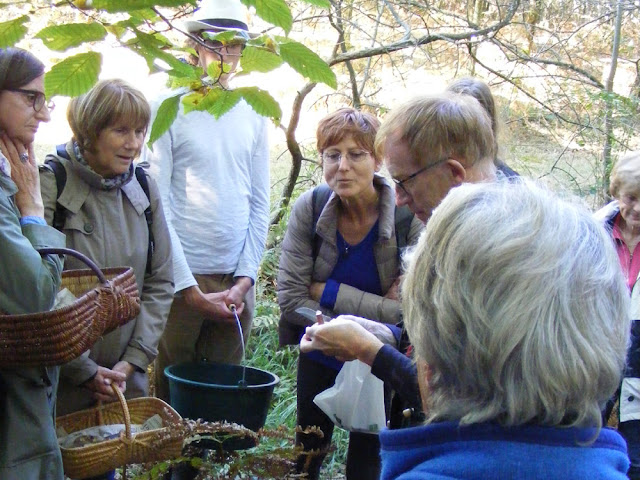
<box><xmin>313</xmin><ymin>360</ymin><xmax>386</xmax><ymax>433</ymax></box>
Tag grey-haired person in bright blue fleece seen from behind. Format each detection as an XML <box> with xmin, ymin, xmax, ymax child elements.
<box><xmin>380</xmin><ymin>178</ymin><xmax>630</xmax><ymax>480</ymax></box>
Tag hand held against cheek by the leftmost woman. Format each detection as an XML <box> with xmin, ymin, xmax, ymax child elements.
<box><xmin>0</xmin><ymin>133</ymin><xmax>44</xmax><ymax>218</ymax></box>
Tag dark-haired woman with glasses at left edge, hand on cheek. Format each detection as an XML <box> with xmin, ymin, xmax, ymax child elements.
<box><xmin>0</xmin><ymin>48</ymin><xmax>65</xmax><ymax>480</ymax></box>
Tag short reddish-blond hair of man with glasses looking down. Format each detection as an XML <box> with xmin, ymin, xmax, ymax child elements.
<box><xmin>375</xmin><ymin>92</ymin><xmax>495</xmax><ymax>167</ymax></box>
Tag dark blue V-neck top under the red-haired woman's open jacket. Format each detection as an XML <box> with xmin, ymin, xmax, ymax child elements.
<box><xmin>307</xmin><ymin>221</ymin><xmax>382</xmax><ymax>370</ymax></box>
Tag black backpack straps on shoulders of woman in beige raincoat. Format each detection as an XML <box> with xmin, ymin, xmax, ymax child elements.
<box><xmin>44</xmin><ymin>143</ymin><xmax>155</xmax><ymax>274</ymax></box>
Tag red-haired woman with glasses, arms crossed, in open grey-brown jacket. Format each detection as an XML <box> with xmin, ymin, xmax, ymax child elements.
<box><xmin>277</xmin><ymin>108</ymin><xmax>422</xmax><ymax>479</ymax></box>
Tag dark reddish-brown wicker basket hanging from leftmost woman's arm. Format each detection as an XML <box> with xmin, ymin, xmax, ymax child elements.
<box><xmin>0</xmin><ymin>248</ymin><xmax>140</xmax><ymax>368</ymax></box>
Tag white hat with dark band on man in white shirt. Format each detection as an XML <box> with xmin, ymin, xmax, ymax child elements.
<box><xmin>184</xmin><ymin>0</ymin><xmax>260</xmax><ymax>40</ymax></box>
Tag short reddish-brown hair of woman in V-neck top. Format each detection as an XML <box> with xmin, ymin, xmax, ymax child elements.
<box><xmin>316</xmin><ymin>107</ymin><xmax>380</xmax><ymax>160</ymax></box>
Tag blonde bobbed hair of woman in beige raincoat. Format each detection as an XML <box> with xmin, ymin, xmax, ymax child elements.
<box><xmin>67</xmin><ymin>79</ymin><xmax>151</xmax><ymax>152</ymax></box>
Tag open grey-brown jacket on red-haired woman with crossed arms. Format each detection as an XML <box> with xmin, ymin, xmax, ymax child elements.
<box><xmin>277</xmin><ymin>175</ymin><xmax>423</xmax><ymax>345</ymax></box>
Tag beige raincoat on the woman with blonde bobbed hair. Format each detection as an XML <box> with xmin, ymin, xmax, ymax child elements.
<box><xmin>40</xmin><ymin>148</ymin><xmax>174</xmax><ymax>414</ymax></box>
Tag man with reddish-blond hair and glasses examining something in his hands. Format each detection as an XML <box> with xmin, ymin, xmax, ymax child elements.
<box><xmin>300</xmin><ymin>92</ymin><xmax>496</xmax><ymax>428</ymax></box>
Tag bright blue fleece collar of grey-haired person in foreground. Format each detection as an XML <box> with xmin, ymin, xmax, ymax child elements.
<box><xmin>380</xmin><ymin>422</ymin><xmax>629</xmax><ymax>480</ymax></box>
